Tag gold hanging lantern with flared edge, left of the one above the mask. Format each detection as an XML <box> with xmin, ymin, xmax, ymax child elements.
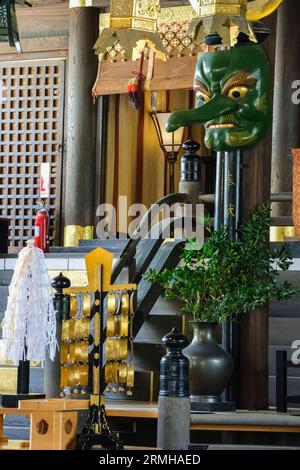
<box><xmin>94</xmin><ymin>0</ymin><xmax>166</xmax><ymax>60</ymax></box>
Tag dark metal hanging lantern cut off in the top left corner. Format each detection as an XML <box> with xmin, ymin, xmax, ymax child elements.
<box><xmin>0</xmin><ymin>0</ymin><xmax>31</xmax><ymax>54</ymax></box>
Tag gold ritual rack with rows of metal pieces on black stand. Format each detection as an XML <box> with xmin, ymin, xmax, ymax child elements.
<box><xmin>61</xmin><ymin>248</ymin><xmax>137</xmax><ymax>450</ymax></box>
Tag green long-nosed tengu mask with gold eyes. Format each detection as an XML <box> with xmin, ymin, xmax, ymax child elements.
<box><xmin>167</xmin><ymin>45</ymin><xmax>272</xmax><ymax>151</ymax></box>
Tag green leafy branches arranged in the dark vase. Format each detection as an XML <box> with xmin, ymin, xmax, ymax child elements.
<box><xmin>144</xmin><ymin>205</ymin><xmax>298</xmax><ymax>323</ymax></box>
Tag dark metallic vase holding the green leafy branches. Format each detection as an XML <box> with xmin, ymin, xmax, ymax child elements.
<box><xmin>183</xmin><ymin>321</ymin><xmax>233</xmax><ymax>405</ymax></box>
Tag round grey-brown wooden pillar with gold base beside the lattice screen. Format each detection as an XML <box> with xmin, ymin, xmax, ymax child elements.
<box><xmin>64</xmin><ymin>7</ymin><xmax>99</xmax><ymax>245</ymax></box>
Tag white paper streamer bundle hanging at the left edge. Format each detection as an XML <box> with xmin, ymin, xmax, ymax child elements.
<box><xmin>2</xmin><ymin>240</ymin><xmax>57</xmax><ymax>364</ymax></box>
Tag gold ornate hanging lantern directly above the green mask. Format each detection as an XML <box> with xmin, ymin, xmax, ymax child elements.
<box><xmin>190</xmin><ymin>0</ymin><xmax>283</xmax><ymax>46</ymax></box>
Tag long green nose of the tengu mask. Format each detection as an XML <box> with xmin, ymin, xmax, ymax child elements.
<box><xmin>166</xmin><ymin>95</ymin><xmax>238</xmax><ymax>132</ymax></box>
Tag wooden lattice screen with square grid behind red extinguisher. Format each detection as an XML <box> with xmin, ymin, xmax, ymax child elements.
<box><xmin>0</xmin><ymin>60</ymin><xmax>65</xmax><ymax>251</ymax></box>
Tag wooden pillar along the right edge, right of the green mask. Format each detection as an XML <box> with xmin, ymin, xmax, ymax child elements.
<box><xmin>272</xmin><ymin>0</ymin><xmax>300</xmax><ymax>216</ymax></box>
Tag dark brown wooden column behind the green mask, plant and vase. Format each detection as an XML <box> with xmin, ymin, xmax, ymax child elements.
<box><xmin>237</xmin><ymin>15</ymin><xmax>276</xmax><ymax>410</ymax></box>
